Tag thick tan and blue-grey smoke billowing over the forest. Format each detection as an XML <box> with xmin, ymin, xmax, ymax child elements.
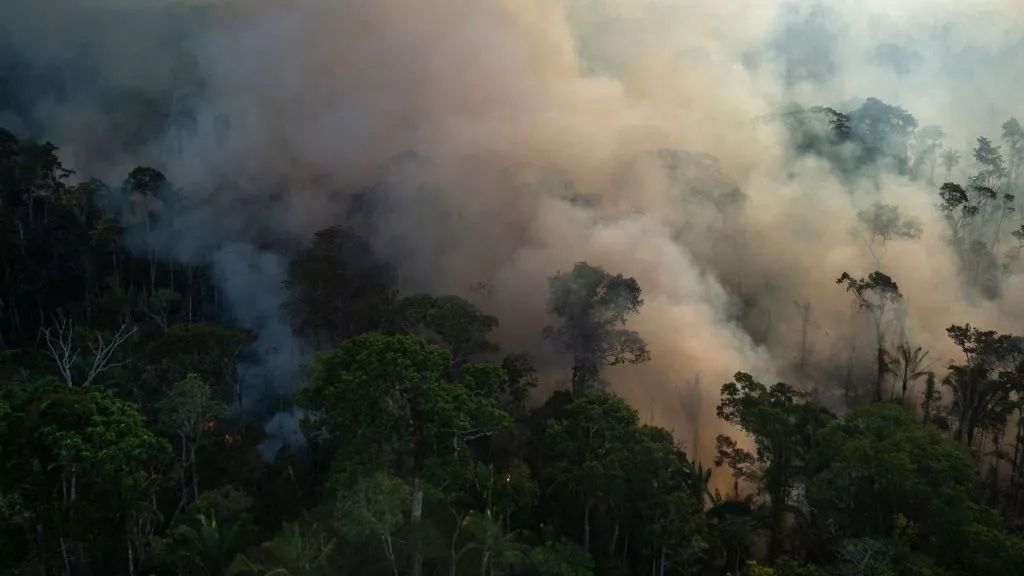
<box><xmin>6</xmin><ymin>0</ymin><xmax>1024</xmax><ymax>456</ymax></box>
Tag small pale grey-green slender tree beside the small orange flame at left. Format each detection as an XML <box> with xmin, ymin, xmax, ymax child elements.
<box><xmin>157</xmin><ymin>374</ymin><xmax>227</xmax><ymax>511</ymax></box>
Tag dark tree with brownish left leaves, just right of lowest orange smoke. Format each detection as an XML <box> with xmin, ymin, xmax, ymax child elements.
<box><xmin>715</xmin><ymin>372</ymin><xmax>830</xmax><ymax>558</ymax></box>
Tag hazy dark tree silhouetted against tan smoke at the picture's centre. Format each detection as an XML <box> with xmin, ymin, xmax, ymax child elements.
<box><xmin>544</xmin><ymin>262</ymin><xmax>650</xmax><ymax>393</ymax></box>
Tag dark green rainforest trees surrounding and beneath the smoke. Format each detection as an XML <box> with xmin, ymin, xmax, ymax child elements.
<box><xmin>0</xmin><ymin>100</ymin><xmax>1024</xmax><ymax>576</ymax></box>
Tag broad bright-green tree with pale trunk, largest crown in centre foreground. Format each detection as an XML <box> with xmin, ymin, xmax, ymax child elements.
<box><xmin>299</xmin><ymin>333</ymin><xmax>509</xmax><ymax>575</ymax></box>
